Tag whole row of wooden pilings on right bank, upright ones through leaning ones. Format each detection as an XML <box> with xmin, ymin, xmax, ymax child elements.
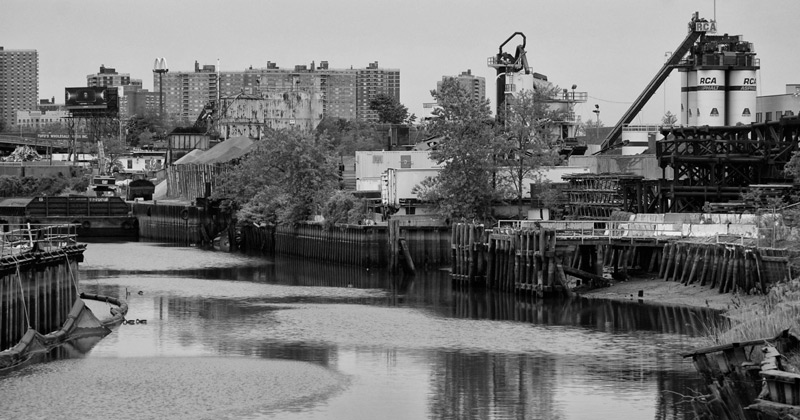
<box><xmin>452</xmin><ymin>224</ymin><xmax>792</xmax><ymax>300</ymax></box>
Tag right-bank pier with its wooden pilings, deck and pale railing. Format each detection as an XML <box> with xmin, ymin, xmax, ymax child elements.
<box><xmin>451</xmin><ymin>214</ymin><xmax>791</xmax><ymax>295</ymax></box>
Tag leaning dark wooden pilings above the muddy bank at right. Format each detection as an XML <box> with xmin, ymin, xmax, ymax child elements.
<box><xmin>658</xmin><ymin>241</ymin><xmax>791</xmax><ymax>294</ymax></box>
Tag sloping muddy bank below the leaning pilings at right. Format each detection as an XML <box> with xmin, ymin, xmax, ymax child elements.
<box><xmin>580</xmin><ymin>276</ymin><xmax>764</xmax><ymax>311</ymax></box>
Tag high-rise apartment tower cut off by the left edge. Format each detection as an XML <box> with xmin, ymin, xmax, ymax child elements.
<box><xmin>0</xmin><ymin>47</ymin><xmax>39</xmax><ymax>130</ymax></box>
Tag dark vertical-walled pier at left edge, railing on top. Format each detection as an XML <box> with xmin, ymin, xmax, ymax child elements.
<box><xmin>0</xmin><ymin>224</ymin><xmax>115</xmax><ymax>368</ymax></box>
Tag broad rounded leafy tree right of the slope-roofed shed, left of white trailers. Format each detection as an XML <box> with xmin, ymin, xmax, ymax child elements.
<box><xmin>214</xmin><ymin>130</ymin><xmax>338</xmax><ymax>224</ymax></box>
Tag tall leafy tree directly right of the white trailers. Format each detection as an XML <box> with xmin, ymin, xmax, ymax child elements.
<box><xmin>417</xmin><ymin>79</ymin><xmax>499</xmax><ymax>220</ymax></box>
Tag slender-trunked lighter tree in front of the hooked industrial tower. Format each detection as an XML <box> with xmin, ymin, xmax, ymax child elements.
<box><xmin>498</xmin><ymin>85</ymin><xmax>569</xmax><ymax>218</ymax></box>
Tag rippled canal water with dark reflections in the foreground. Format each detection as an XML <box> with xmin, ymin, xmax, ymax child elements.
<box><xmin>0</xmin><ymin>242</ymin><xmax>715</xmax><ymax>419</ymax></box>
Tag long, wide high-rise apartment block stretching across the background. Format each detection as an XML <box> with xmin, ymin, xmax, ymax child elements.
<box><xmin>159</xmin><ymin>61</ymin><xmax>400</xmax><ymax>122</ymax></box>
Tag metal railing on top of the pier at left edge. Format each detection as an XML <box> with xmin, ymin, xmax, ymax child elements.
<box><xmin>0</xmin><ymin>224</ymin><xmax>80</xmax><ymax>257</ymax></box>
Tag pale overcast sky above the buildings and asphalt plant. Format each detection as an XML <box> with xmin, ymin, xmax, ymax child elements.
<box><xmin>0</xmin><ymin>0</ymin><xmax>800</xmax><ymax>126</ymax></box>
